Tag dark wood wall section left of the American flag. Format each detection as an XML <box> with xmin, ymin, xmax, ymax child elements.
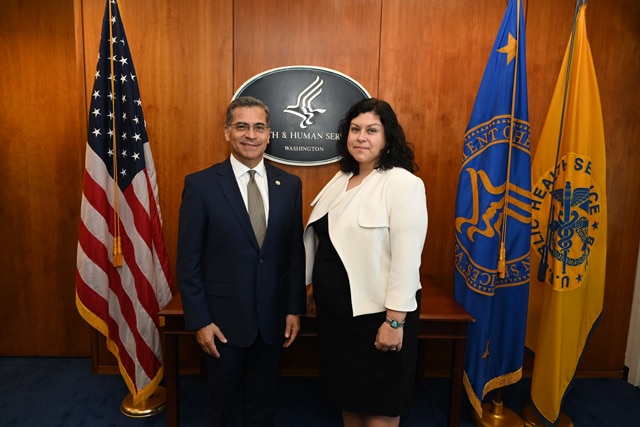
<box><xmin>0</xmin><ymin>0</ymin><xmax>89</xmax><ymax>356</ymax></box>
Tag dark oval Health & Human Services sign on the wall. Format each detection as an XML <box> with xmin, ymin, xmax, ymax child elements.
<box><xmin>233</xmin><ymin>66</ymin><xmax>370</xmax><ymax>166</ymax></box>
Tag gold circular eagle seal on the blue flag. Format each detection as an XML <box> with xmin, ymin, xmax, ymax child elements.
<box><xmin>455</xmin><ymin>115</ymin><xmax>531</xmax><ymax>296</ymax></box>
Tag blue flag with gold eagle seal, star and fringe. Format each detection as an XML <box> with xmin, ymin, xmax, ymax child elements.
<box><xmin>454</xmin><ymin>0</ymin><xmax>531</xmax><ymax>418</ymax></box>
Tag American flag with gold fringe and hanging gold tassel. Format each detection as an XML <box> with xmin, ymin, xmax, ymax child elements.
<box><xmin>76</xmin><ymin>0</ymin><xmax>172</xmax><ymax>405</ymax></box>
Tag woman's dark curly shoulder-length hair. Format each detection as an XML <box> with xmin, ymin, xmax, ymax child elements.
<box><xmin>337</xmin><ymin>98</ymin><xmax>418</xmax><ymax>175</ymax></box>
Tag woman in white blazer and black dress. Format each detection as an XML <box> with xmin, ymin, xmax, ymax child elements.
<box><xmin>304</xmin><ymin>98</ymin><xmax>427</xmax><ymax>426</ymax></box>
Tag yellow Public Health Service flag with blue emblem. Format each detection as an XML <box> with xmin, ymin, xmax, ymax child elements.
<box><xmin>525</xmin><ymin>1</ymin><xmax>607</xmax><ymax>422</ymax></box>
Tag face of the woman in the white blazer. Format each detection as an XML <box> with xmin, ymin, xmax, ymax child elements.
<box><xmin>347</xmin><ymin>112</ymin><xmax>387</xmax><ymax>172</ymax></box>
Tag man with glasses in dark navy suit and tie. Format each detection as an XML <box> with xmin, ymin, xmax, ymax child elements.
<box><xmin>177</xmin><ymin>97</ymin><xmax>306</xmax><ymax>426</ymax></box>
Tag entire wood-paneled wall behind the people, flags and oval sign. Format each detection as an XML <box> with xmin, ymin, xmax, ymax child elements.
<box><xmin>0</xmin><ymin>0</ymin><xmax>640</xmax><ymax>376</ymax></box>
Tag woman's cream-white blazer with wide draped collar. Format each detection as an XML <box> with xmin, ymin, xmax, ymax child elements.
<box><xmin>304</xmin><ymin>168</ymin><xmax>428</xmax><ymax>316</ymax></box>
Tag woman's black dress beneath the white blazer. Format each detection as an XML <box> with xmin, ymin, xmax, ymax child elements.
<box><xmin>312</xmin><ymin>215</ymin><xmax>420</xmax><ymax>416</ymax></box>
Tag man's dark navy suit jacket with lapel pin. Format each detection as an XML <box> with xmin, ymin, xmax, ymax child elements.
<box><xmin>177</xmin><ymin>158</ymin><xmax>306</xmax><ymax>427</ymax></box>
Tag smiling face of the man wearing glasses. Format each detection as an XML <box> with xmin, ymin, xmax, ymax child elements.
<box><xmin>224</xmin><ymin>107</ymin><xmax>270</xmax><ymax>168</ymax></box>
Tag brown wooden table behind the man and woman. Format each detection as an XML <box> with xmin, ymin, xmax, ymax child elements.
<box><xmin>159</xmin><ymin>277</ymin><xmax>473</xmax><ymax>427</ymax></box>
